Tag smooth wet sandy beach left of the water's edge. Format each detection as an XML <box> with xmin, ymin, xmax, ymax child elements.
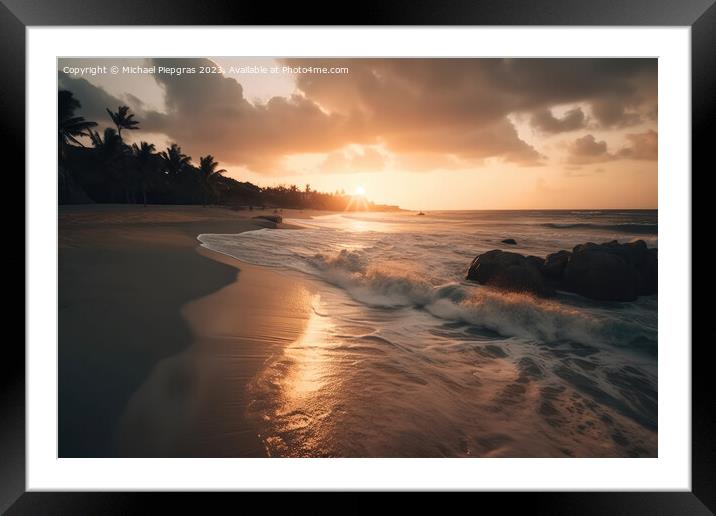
<box><xmin>58</xmin><ymin>205</ymin><xmax>318</xmax><ymax>457</ymax></box>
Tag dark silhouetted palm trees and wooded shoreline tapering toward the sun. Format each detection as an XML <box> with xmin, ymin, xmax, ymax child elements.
<box><xmin>58</xmin><ymin>90</ymin><xmax>397</xmax><ymax>211</ymax></box>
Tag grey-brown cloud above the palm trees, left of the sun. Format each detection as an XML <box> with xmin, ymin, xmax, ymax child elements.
<box><xmin>137</xmin><ymin>59</ymin><xmax>364</xmax><ymax>172</ymax></box>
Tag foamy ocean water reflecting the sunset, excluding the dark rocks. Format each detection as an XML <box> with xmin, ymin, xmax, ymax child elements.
<box><xmin>199</xmin><ymin>210</ymin><xmax>658</xmax><ymax>457</ymax></box>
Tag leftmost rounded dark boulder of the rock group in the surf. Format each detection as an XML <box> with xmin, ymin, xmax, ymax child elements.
<box><xmin>467</xmin><ymin>249</ymin><xmax>551</xmax><ymax>296</ymax></box>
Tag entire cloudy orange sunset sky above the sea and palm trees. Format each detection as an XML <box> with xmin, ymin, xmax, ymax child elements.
<box><xmin>58</xmin><ymin>57</ymin><xmax>657</xmax><ymax>210</ymax></box>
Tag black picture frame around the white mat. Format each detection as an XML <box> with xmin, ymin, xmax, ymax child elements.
<box><xmin>0</xmin><ymin>0</ymin><xmax>716</xmax><ymax>514</ymax></box>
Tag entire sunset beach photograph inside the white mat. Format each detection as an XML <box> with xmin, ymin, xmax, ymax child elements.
<box><xmin>57</xmin><ymin>56</ymin><xmax>656</xmax><ymax>459</ymax></box>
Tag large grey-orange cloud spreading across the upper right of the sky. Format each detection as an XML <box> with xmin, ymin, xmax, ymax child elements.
<box><xmin>284</xmin><ymin>59</ymin><xmax>657</xmax><ymax>165</ymax></box>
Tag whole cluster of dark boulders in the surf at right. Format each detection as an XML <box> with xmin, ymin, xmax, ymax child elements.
<box><xmin>467</xmin><ymin>240</ymin><xmax>658</xmax><ymax>301</ymax></box>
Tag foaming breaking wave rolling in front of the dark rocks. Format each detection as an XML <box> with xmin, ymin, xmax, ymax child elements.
<box><xmin>309</xmin><ymin>250</ymin><xmax>645</xmax><ymax>345</ymax></box>
